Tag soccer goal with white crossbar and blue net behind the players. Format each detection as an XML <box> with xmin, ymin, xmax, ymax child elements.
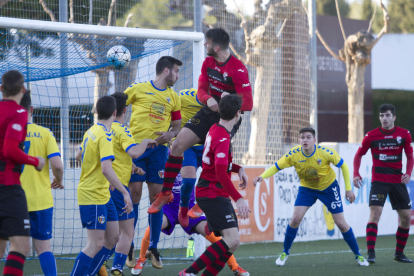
<box><xmin>0</xmin><ymin>18</ymin><xmax>204</xmax><ymax>258</ymax></box>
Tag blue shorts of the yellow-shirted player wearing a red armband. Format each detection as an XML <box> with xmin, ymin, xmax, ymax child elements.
<box><xmin>129</xmin><ymin>145</ymin><xmax>168</xmax><ymax>184</ymax></box>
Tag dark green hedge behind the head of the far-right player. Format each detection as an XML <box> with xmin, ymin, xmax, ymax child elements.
<box><xmin>372</xmin><ymin>89</ymin><xmax>414</xmax><ymax>135</ymax></box>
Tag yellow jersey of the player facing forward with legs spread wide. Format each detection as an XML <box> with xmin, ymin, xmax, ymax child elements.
<box><xmin>275</xmin><ymin>145</ymin><xmax>344</xmax><ymax>191</ymax></box>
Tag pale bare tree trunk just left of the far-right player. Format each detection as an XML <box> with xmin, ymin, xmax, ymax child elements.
<box><xmin>347</xmin><ymin>63</ymin><xmax>366</xmax><ymax>143</ymax></box>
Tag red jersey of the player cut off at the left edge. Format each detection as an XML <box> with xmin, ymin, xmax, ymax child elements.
<box><xmin>0</xmin><ymin>100</ymin><xmax>27</xmax><ymax>185</ymax></box>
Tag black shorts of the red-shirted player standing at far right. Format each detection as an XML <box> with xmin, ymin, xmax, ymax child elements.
<box><xmin>369</xmin><ymin>181</ymin><xmax>411</xmax><ymax>210</ymax></box>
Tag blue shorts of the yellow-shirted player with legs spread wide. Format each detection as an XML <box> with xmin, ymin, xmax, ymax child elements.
<box><xmin>295</xmin><ymin>180</ymin><xmax>344</xmax><ymax>214</ymax></box>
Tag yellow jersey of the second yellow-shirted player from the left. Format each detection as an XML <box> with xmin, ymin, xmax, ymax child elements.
<box><xmin>78</xmin><ymin>123</ymin><xmax>115</xmax><ymax>205</ymax></box>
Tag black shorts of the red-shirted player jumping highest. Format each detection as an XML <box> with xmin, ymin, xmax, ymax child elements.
<box><xmin>184</xmin><ymin>106</ymin><xmax>242</xmax><ymax>144</ymax></box>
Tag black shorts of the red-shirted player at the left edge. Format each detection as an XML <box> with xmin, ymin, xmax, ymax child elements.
<box><xmin>0</xmin><ymin>185</ymin><xmax>30</xmax><ymax>240</ymax></box>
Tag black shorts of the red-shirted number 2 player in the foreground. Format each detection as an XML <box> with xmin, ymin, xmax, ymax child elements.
<box><xmin>197</xmin><ymin>196</ymin><xmax>239</xmax><ymax>237</ymax></box>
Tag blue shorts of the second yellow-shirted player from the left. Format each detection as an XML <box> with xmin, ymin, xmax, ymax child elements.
<box><xmin>79</xmin><ymin>198</ymin><xmax>118</xmax><ymax>230</ymax></box>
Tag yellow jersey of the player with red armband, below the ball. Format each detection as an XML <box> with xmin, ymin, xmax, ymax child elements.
<box><xmin>124</xmin><ymin>81</ymin><xmax>181</xmax><ymax>143</ymax></box>
